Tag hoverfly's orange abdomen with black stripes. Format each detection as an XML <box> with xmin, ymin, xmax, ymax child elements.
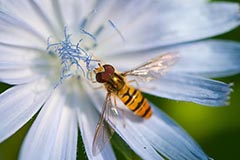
<box><xmin>118</xmin><ymin>84</ymin><xmax>152</xmax><ymax>118</ymax></box>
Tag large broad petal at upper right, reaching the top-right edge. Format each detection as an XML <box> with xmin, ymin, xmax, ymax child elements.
<box><xmin>95</xmin><ymin>2</ymin><xmax>240</xmax><ymax>55</ymax></box>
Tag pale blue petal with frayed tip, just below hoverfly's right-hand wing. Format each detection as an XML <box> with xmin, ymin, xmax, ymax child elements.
<box><xmin>139</xmin><ymin>73</ymin><xmax>231</xmax><ymax>106</ymax></box>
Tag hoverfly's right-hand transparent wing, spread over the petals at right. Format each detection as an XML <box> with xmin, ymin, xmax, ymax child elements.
<box><xmin>122</xmin><ymin>53</ymin><xmax>179</xmax><ymax>82</ymax></box>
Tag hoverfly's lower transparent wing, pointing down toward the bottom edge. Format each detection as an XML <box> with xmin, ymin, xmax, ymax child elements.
<box><xmin>92</xmin><ymin>93</ymin><xmax>118</xmax><ymax>156</ymax></box>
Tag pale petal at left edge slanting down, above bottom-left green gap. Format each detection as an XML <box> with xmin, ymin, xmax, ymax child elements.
<box><xmin>0</xmin><ymin>81</ymin><xmax>51</xmax><ymax>142</ymax></box>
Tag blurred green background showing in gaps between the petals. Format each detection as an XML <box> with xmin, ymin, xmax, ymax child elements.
<box><xmin>0</xmin><ymin>0</ymin><xmax>240</xmax><ymax>160</ymax></box>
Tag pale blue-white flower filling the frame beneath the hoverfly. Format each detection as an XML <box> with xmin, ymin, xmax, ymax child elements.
<box><xmin>0</xmin><ymin>0</ymin><xmax>240</xmax><ymax>160</ymax></box>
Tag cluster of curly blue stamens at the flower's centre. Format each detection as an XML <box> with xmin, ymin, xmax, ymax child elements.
<box><xmin>47</xmin><ymin>27</ymin><xmax>100</xmax><ymax>87</ymax></box>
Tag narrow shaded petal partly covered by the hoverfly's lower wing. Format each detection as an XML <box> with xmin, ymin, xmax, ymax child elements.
<box><xmin>75</xmin><ymin>85</ymin><xmax>116</xmax><ymax>160</ymax></box>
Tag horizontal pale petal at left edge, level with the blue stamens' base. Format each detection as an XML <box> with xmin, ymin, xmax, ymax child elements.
<box><xmin>0</xmin><ymin>44</ymin><xmax>54</xmax><ymax>84</ymax></box>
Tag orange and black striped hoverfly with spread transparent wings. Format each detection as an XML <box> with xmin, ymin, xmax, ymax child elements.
<box><xmin>92</xmin><ymin>53</ymin><xmax>178</xmax><ymax>156</ymax></box>
